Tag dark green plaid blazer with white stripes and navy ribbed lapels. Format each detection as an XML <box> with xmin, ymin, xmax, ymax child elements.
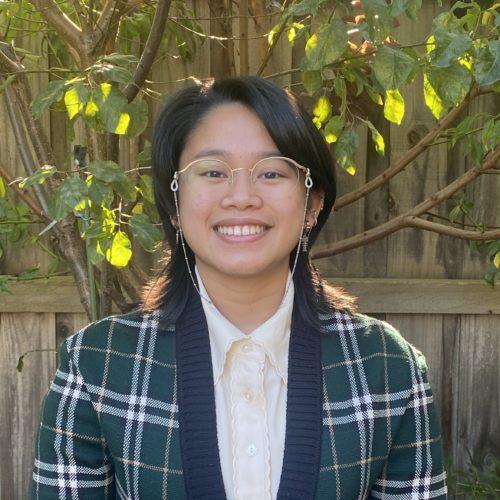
<box><xmin>31</xmin><ymin>293</ymin><xmax>446</xmax><ymax>500</ymax></box>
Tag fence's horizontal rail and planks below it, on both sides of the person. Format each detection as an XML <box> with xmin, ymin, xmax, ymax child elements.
<box><xmin>0</xmin><ymin>278</ymin><xmax>500</xmax><ymax>500</ymax></box>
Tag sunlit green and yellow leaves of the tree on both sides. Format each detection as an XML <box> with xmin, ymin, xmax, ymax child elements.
<box><xmin>0</xmin><ymin>0</ymin><xmax>500</xmax><ymax>318</ymax></box>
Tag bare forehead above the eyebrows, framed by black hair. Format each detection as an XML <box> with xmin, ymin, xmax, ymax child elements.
<box><xmin>181</xmin><ymin>103</ymin><xmax>279</xmax><ymax>162</ymax></box>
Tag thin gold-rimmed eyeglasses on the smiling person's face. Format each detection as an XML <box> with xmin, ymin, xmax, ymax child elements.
<box><xmin>171</xmin><ymin>156</ymin><xmax>312</xmax><ymax>196</ymax></box>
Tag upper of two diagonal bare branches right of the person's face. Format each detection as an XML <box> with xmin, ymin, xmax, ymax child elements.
<box><xmin>333</xmin><ymin>87</ymin><xmax>483</xmax><ymax>210</ymax></box>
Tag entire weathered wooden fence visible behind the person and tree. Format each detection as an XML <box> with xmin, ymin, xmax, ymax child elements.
<box><xmin>0</xmin><ymin>0</ymin><xmax>500</xmax><ymax>500</ymax></box>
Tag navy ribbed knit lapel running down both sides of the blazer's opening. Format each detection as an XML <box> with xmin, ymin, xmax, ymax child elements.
<box><xmin>175</xmin><ymin>287</ymin><xmax>323</xmax><ymax>500</ymax></box>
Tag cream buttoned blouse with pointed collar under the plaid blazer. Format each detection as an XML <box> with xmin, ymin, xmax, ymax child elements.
<box><xmin>195</xmin><ymin>267</ymin><xmax>294</xmax><ymax>500</ymax></box>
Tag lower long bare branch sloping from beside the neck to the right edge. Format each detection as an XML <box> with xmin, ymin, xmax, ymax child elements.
<box><xmin>311</xmin><ymin>147</ymin><xmax>500</xmax><ymax>259</ymax></box>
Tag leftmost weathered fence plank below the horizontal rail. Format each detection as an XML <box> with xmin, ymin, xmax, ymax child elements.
<box><xmin>0</xmin><ymin>313</ymin><xmax>55</xmax><ymax>500</ymax></box>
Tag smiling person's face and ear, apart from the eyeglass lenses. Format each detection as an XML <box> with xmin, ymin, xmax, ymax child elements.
<box><xmin>178</xmin><ymin>103</ymin><xmax>322</xmax><ymax>282</ymax></box>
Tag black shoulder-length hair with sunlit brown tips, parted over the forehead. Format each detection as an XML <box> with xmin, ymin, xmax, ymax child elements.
<box><xmin>142</xmin><ymin>76</ymin><xmax>353</xmax><ymax>326</ymax></box>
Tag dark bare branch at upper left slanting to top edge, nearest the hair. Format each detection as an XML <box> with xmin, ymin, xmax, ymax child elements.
<box><xmin>123</xmin><ymin>0</ymin><xmax>171</xmax><ymax>102</ymax></box>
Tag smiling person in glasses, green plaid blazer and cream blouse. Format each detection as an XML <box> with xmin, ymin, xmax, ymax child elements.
<box><xmin>32</xmin><ymin>77</ymin><xmax>446</xmax><ymax>500</ymax></box>
